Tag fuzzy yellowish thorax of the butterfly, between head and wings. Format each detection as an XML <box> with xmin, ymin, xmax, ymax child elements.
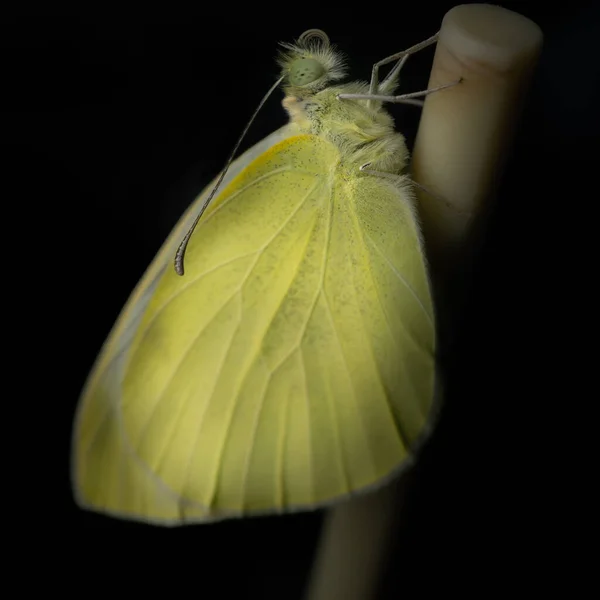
<box><xmin>282</xmin><ymin>83</ymin><xmax>408</xmax><ymax>174</ymax></box>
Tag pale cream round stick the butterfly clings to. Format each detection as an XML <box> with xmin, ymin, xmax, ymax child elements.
<box><xmin>306</xmin><ymin>4</ymin><xmax>542</xmax><ymax>600</ymax></box>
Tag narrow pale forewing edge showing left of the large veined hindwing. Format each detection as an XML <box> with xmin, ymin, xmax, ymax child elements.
<box><xmin>71</xmin><ymin>125</ymin><xmax>290</xmax><ymax>524</ymax></box>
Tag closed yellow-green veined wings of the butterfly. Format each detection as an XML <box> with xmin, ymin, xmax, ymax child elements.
<box><xmin>74</xmin><ymin>130</ymin><xmax>435</xmax><ymax>525</ymax></box>
